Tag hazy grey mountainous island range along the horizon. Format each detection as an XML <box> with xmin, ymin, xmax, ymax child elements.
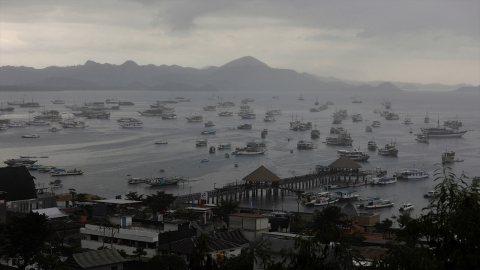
<box><xmin>0</xmin><ymin>56</ymin><xmax>469</xmax><ymax>93</ymax></box>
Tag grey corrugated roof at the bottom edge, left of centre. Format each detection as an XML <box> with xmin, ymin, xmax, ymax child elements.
<box><xmin>73</xmin><ymin>249</ymin><xmax>127</xmax><ymax>268</ymax></box>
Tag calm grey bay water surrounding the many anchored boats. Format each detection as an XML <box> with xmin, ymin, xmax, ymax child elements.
<box><xmin>0</xmin><ymin>91</ymin><xmax>480</xmax><ymax>218</ymax></box>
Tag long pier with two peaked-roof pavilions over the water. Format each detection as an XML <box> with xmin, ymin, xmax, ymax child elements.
<box><xmin>176</xmin><ymin>156</ymin><xmax>376</xmax><ymax>204</ymax></box>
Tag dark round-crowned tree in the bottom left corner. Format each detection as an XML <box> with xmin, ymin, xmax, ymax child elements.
<box><xmin>2</xmin><ymin>212</ymin><xmax>50</xmax><ymax>269</ymax></box>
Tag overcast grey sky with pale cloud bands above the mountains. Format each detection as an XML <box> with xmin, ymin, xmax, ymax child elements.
<box><xmin>0</xmin><ymin>0</ymin><xmax>480</xmax><ymax>85</ymax></box>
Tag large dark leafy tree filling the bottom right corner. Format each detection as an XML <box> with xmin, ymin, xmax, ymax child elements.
<box><xmin>375</xmin><ymin>167</ymin><xmax>480</xmax><ymax>269</ymax></box>
